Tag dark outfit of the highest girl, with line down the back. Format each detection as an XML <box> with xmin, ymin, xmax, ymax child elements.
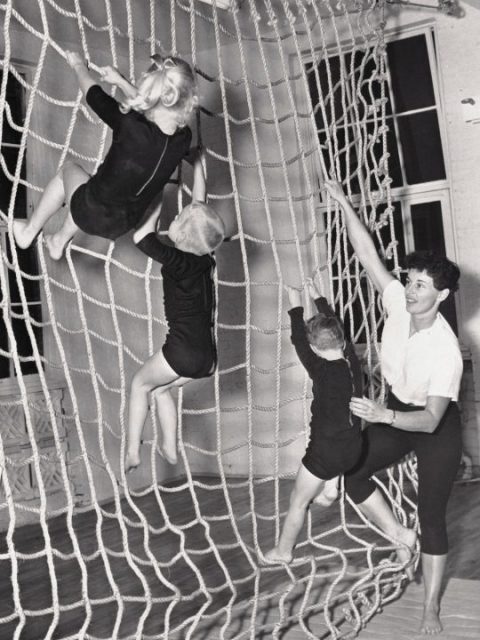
<box><xmin>70</xmin><ymin>85</ymin><xmax>192</xmax><ymax>240</ymax></box>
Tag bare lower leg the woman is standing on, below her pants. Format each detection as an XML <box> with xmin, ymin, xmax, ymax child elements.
<box><xmin>420</xmin><ymin>553</ymin><xmax>447</xmax><ymax>635</ymax></box>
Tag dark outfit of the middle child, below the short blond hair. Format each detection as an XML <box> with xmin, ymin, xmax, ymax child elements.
<box><xmin>137</xmin><ymin>233</ymin><xmax>217</xmax><ymax>378</ymax></box>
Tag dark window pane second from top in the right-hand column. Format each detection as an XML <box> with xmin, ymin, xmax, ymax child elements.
<box><xmin>398</xmin><ymin>111</ymin><xmax>445</xmax><ymax>184</ymax></box>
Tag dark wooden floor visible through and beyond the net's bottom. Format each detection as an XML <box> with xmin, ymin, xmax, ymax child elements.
<box><xmin>0</xmin><ymin>478</ymin><xmax>480</xmax><ymax>640</ymax></box>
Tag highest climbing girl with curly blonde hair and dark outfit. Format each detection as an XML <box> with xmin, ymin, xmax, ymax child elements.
<box><xmin>13</xmin><ymin>51</ymin><xmax>198</xmax><ymax>260</ymax></box>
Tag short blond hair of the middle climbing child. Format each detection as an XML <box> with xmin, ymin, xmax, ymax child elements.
<box><xmin>182</xmin><ymin>201</ymin><xmax>225</xmax><ymax>255</ymax></box>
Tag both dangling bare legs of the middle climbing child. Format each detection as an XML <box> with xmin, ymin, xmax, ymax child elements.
<box><xmin>125</xmin><ymin>351</ymin><xmax>191</xmax><ymax>471</ymax></box>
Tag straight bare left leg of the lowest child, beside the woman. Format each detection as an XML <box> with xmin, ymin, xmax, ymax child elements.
<box><xmin>265</xmin><ymin>464</ymin><xmax>324</xmax><ymax>563</ymax></box>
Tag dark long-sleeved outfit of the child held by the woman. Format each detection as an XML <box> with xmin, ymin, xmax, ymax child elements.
<box><xmin>289</xmin><ymin>297</ymin><xmax>362</xmax><ymax>480</ymax></box>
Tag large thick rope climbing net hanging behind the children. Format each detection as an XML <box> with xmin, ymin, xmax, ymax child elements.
<box><xmin>0</xmin><ymin>0</ymin><xmax>416</xmax><ymax>640</ymax></box>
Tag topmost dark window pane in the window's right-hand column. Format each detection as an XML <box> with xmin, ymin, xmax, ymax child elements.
<box><xmin>387</xmin><ymin>35</ymin><xmax>435</xmax><ymax>113</ymax></box>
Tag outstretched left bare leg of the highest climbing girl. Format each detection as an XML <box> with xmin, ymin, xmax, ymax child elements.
<box><xmin>13</xmin><ymin>162</ymin><xmax>90</xmax><ymax>252</ymax></box>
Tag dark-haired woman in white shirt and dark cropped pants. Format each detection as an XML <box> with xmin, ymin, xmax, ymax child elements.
<box><xmin>325</xmin><ymin>180</ymin><xmax>462</xmax><ymax>634</ymax></box>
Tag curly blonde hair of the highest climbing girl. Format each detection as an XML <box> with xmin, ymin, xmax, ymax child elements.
<box><xmin>121</xmin><ymin>55</ymin><xmax>198</xmax><ymax>127</ymax></box>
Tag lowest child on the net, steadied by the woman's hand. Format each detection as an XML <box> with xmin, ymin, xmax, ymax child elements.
<box><xmin>265</xmin><ymin>279</ymin><xmax>362</xmax><ymax>563</ymax></box>
